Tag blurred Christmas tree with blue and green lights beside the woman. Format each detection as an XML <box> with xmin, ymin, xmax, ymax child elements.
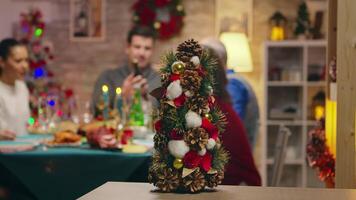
<box><xmin>18</xmin><ymin>8</ymin><xmax>76</xmax><ymax>131</ymax></box>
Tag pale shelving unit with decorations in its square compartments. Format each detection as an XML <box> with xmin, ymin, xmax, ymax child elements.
<box><xmin>261</xmin><ymin>40</ymin><xmax>326</xmax><ymax>187</ymax></box>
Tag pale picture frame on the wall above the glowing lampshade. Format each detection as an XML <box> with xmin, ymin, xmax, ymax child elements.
<box><xmin>215</xmin><ymin>0</ymin><xmax>253</xmax><ymax>40</ymax></box>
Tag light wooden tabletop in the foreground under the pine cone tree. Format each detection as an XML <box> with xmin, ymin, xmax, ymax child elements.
<box><xmin>79</xmin><ymin>182</ymin><xmax>356</xmax><ymax>200</ymax></box>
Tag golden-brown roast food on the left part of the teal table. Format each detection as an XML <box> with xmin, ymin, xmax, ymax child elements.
<box><xmin>45</xmin><ymin>130</ymin><xmax>82</xmax><ymax>147</ymax></box>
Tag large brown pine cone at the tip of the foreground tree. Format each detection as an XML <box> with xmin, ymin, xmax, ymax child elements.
<box><xmin>176</xmin><ymin>39</ymin><xmax>203</xmax><ymax>62</ymax></box>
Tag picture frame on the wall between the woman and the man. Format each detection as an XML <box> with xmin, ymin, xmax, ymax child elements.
<box><xmin>69</xmin><ymin>0</ymin><xmax>106</xmax><ymax>42</ymax></box>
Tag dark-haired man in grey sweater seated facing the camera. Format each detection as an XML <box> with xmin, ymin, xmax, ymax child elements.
<box><xmin>92</xmin><ymin>26</ymin><xmax>160</xmax><ymax>115</ymax></box>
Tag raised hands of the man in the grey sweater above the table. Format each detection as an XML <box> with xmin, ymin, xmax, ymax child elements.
<box><xmin>122</xmin><ymin>74</ymin><xmax>148</xmax><ymax>99</ymax></box>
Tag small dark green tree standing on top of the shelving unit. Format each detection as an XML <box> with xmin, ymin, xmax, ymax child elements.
<box><xmin>294</xmin><ymin>2</ymin><xmax>310</xmax><ymax>37</ymax></box>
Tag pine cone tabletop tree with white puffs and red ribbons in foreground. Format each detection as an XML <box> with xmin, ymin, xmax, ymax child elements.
<box><xmin>149</xmin><ymin>40</ymin><xmax>228</xmax><ymax>192</ymax></box>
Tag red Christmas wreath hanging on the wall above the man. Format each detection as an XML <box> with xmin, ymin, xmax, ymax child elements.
<box><xmin>132</xmin><ymin>0</ymin><xmax>185</xmax><ymax>39</ymax></box>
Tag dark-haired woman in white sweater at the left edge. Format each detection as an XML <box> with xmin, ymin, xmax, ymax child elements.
<box><xmin>0</xmin><ymin>38</ymin><xmax>30</xmax><ymax>140</ymax></box>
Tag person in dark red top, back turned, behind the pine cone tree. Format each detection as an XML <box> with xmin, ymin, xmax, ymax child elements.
<box><xmin>203</xmin><ymin>40</ymin><xmax>261</xmax><ymax>186</ymax></box>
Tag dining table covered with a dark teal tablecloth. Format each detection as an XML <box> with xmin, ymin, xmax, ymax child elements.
<box><xmin>0</xmin><ymin>135</ymin><xmax>151</xmax><ymax>200</ymax></box>
